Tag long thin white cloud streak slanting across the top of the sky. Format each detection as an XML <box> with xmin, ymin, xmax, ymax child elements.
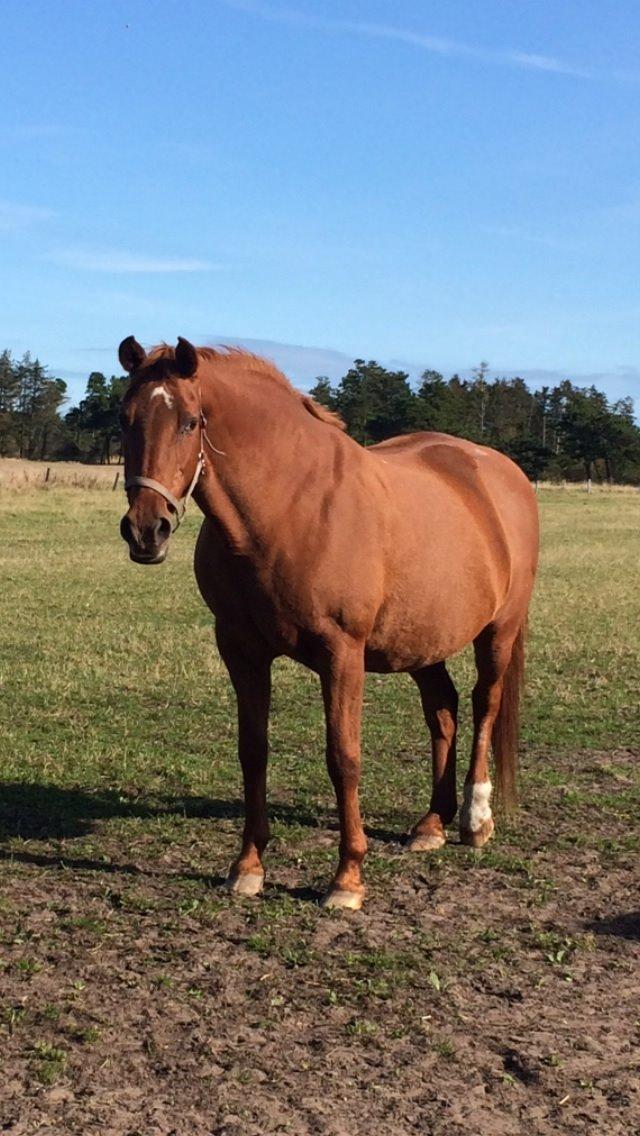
<box><xmin>219</xmin><ymin>0</ymin><xmax>597</xmax><ymax>80</ymax></box>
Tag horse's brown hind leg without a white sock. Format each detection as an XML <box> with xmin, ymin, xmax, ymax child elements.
<box><xmin>408</xmin><ymin>662</ymin><xmax>458</xmax><ymax>852</ymax></box>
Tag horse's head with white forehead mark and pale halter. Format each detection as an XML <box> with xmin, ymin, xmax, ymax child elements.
<box><xmin>118</xmin><ymin>335</ymin><xmax>203</xmax><ymax>565</ymax></box>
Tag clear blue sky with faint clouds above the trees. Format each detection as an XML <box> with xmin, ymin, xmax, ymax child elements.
<box><xmin>0</xmin><ymin>0</ymin><xmax>640</xmax><ymax>408</ymax></box>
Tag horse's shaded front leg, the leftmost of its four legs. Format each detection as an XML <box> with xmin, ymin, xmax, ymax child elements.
<box><xmin>217</xmin><ymin>630</ymin><xmax>272</xmax><ymax>895</ymax></box>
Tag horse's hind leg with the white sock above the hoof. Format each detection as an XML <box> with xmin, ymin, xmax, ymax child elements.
<box><xmin>460</xmin><ymin>624</ymin><xmax>518</xmax><ymax>847</ymax></box>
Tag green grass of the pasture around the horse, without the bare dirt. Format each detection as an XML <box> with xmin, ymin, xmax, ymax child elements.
<box><xmin>0</xmin><ymin>479</ymin><xmax>640</xmax><ymax>876</ymax></box>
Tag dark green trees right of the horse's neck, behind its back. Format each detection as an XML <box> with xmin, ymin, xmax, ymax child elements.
<box><xmin>310</xmin><ymin>359</ymin><xmax>640</xmax><ymax>483</ymax></box>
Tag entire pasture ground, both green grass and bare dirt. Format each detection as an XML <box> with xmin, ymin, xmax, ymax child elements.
<box><xmin>0</xmin><ymin>486</ymin><xmax>640</xmax><ymax>1136</ymax></box>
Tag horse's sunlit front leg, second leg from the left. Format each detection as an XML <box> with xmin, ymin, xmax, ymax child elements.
<box><xmin>321</xmin><ymin>641</ymin><xmax>367</xmax><ymax>910</ymax></box>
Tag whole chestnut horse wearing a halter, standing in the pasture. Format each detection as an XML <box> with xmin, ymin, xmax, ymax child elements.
<box><xmin>119</xmin><ymin>336</ymin><xmax>538</xmax><ymax>908</ymax></box>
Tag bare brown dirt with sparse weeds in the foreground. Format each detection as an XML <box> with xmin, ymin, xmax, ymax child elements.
<box><xmin>0</xmin><ymin>752</ymin><xmax>640</xmax><ymax>1136</ymax></box>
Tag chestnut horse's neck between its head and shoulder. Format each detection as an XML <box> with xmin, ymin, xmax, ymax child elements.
<box><xmin>196</xmin><ymin>356</ymin><xmax>325</xmax><ymax>553</ymax></box>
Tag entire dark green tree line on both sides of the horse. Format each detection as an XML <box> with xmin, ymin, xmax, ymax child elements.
<box><xmin>0</xmin><ymin>351</ymin><xmax>640</xmax><ymax>484</ymax></box>
